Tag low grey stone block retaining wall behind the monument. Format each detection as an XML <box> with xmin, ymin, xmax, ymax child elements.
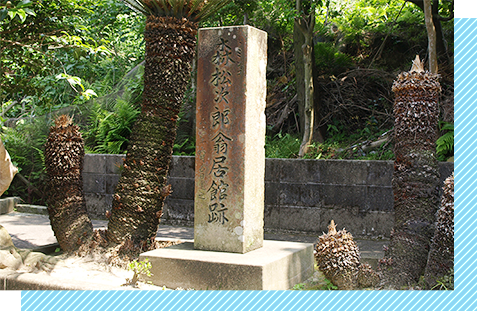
<box><xmin>83</xmin><ymin>154</ymin><xmax>454</xmax><ymax>237</ymax></box>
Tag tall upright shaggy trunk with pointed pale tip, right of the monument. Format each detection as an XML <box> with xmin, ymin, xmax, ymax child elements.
<box><xmin>380</xmin><ymin>57</ymin><xmax>440</xmax><ymax>288</ymax></box>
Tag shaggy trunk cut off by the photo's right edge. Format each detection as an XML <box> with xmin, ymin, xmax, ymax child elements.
<box><xmin>424</xmin><ymin>173</ymin><xmax>454</xmax><ymax>288</ymax></box>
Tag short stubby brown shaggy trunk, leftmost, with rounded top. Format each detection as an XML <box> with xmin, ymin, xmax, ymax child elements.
<box><xmin>45</xmin><ymin>115</ymin><xmax>93</xmax><ymax>252</ymax></box>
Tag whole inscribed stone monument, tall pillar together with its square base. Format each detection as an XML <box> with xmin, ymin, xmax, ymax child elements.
<box><xmin>140</xmin><ymin>26</ymin><xmax>314</xmax><ymax>290</ymax></box>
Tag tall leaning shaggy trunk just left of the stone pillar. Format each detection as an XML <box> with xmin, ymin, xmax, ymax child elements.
<box><xmin>107</xmin><ymin>15</ymin><xmax>198</xmax><ymax>244</ymax></box>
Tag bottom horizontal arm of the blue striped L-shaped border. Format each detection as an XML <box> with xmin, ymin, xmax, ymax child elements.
<box><xmin>22</xmin><ymin>290</ymin><xmax>464</xmax><ymax>311</ymax></box>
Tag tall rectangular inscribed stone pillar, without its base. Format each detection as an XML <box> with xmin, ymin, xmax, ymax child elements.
<box><xmin>194</xmin><ymin>26</ymin><xmax>267</xmax><ymax>253</ymax></box>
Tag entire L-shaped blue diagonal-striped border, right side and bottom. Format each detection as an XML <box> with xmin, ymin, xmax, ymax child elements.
<box><xmin>21</xmin><ymin>19</ymin><xmax>470</xmax><ymax>311</ymax></box>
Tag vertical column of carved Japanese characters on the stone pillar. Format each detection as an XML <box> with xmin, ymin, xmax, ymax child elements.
<box><xmin>207</xmin><ymin>37</ymin><xmax>241</xmax><ymax>225</ymax></box>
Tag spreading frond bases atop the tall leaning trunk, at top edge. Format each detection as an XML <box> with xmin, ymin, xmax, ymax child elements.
<box><xmin>119</xmin><ymin>0</ymin><xmax>232</xmax><ymax>22</ymax></box>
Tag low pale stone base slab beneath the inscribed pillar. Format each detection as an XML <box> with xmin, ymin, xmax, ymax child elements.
<box><xmin>139</xmin><ymin>240</ymin><xmax>314</xmax><ymax>290</ymax></box>
